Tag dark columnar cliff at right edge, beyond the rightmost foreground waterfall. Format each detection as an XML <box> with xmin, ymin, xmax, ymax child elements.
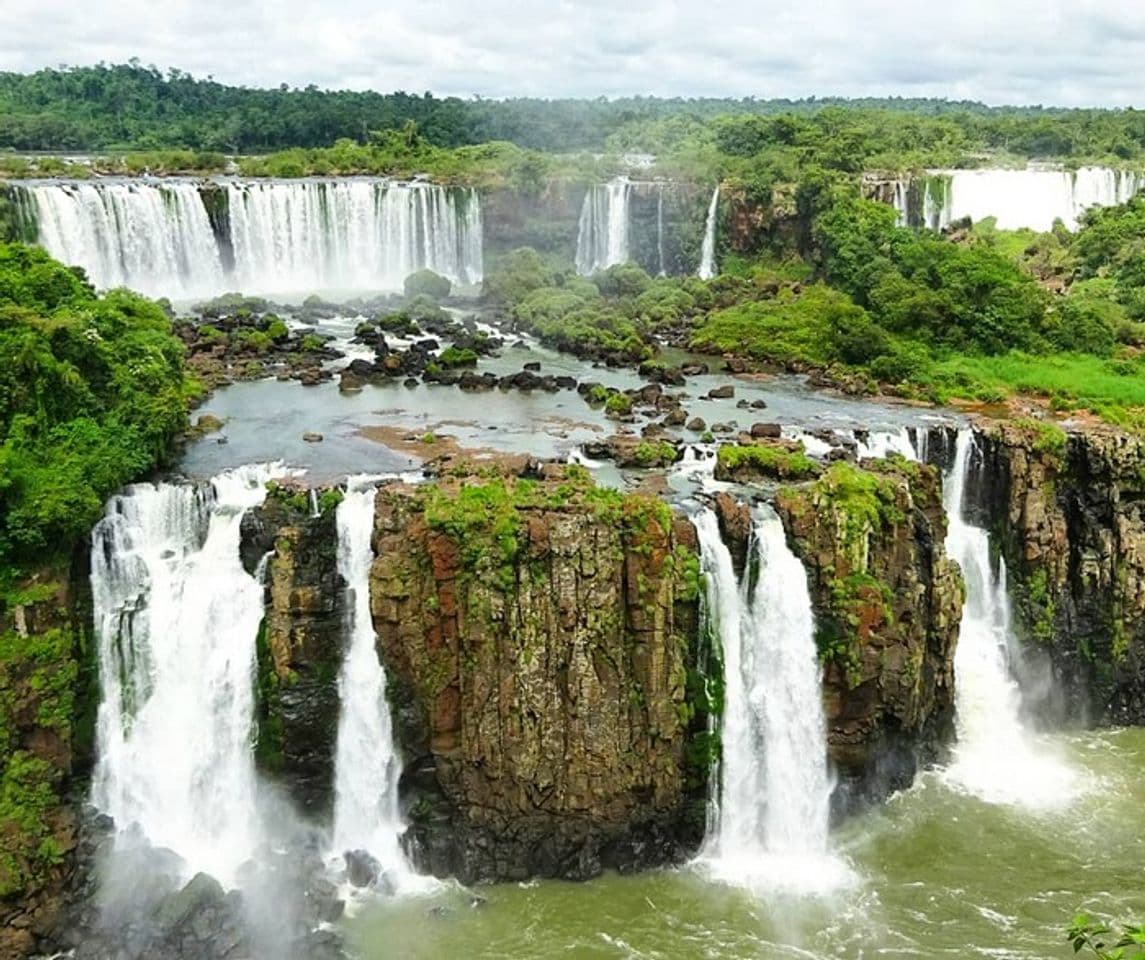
<box><xmin>968</xmin><ymin>420</ymin><xmax>1145</xmax><ymax>724</ymax></box>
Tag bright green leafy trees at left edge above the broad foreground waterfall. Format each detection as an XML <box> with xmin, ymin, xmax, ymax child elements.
<box><xmin>0</xmin><ymin>244</ymin><xmax>197</xmax><ymax>570</ymax></box>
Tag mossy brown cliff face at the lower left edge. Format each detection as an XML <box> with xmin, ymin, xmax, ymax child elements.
<box><xmin>0</xmin><ymin>562</ymin><xmax>94</xmax><ymax>960</ymax></box>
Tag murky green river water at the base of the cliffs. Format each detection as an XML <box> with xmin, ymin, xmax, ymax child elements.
<box><xmin>346</xmin><ymin>730</ymin><xmax>1145</xmax><ymax>960</ymax></box>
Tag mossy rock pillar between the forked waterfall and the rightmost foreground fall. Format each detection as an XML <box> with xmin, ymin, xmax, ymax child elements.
<box><xmin>775</xmin><ymin>458</ymin><xmax>963</xmax><ymax>812</ymax></box>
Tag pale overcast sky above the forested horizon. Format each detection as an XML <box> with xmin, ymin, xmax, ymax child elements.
<box><xmin>0</xmin><ymin>0</ymin><xmax>1145</xmax><ymax>107</ymax></box>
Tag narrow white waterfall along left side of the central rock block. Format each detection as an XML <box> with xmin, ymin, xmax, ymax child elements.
<box><xmin>334</xmin><ymin>478</ymin><xmax>408</xmax><ymax>881</ymax></box>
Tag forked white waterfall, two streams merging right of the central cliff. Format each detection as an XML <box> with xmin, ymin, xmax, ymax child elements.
<box><xmin>695</xmin><ymin>510</ymin><xmax>845</xmax><ymax>892</ymax></box>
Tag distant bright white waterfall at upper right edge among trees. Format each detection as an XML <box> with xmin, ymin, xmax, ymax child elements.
<box><xmin>893</xmin><ymin>166</ymin><xmax>1145</xmax><ymax>230</ymax></box>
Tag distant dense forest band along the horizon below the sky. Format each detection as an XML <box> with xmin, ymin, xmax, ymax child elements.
<box><xmin>0</xmin><ymin>62</ymin><xmax>1145</xmax><ymax>162</ymax></box>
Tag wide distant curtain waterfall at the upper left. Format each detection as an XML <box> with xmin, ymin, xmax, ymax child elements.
<box><xmin>14</xmin><ymin>178</ymin><xmax>483</xmax><ymax>299</ymax></box>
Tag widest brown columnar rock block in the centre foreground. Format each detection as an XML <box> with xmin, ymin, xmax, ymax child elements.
<box><xmin>371</xmin><ymin>467</ymin><xmax>702</xmax><ymax>881</ymax></box>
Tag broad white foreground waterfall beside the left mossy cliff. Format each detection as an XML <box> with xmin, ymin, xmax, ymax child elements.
<box><xmin>92</xmin><ymin>467</ymin><xmax>275</xmax><ymax>883</ymax></box>
